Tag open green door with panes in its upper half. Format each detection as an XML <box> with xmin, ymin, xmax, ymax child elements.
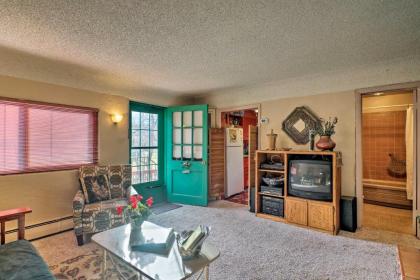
<box><xmin>165</xmin><ymin>105</ymin><xmax>208</xmax><ymax>206</ymax></box>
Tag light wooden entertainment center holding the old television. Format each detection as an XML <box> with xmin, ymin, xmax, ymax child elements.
<box><xmin>255</xmin><ymin>150</ymin><xmax>341</xmax><ymax>235</ymax></box>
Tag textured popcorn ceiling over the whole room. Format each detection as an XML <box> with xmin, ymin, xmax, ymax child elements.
<box><xmin>0</xmin><ymin>0</ymin><xmax>420</xmax><ymax>97</ymax></box>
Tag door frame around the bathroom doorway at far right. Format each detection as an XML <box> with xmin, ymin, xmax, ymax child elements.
<box><xmin>355</xmin><ymin>81</ymin><xmax>420</xmax><ymax>234</ymax></box>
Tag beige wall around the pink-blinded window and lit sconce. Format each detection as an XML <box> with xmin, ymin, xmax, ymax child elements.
<box><xmin>0</xmin><ymin>76</ymin><xmax>159</xmax><ymax>236</ymax></box>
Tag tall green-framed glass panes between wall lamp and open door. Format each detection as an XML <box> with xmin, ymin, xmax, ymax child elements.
<box><xmin>129</xmin><ymin>102</ymin><xmax>165</xmax><ymax>203</ymax></box>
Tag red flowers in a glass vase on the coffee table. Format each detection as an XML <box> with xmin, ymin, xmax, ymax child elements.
<box><xmin>117</xmin><ymin>194</ymin><xmax>153</xmax><ymax>228</ymax></box>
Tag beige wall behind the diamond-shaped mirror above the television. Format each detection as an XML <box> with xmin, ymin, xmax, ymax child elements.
<box><xmin>260</xmin><ymin>92</ymin><xmax>355</xmax><ymax>195</ymax></box>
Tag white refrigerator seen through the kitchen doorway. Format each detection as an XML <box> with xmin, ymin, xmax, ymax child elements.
<box><xmin>225</xmin><ymin>128</ymin><xmax>244</xmax><ymax>197</ymax></box>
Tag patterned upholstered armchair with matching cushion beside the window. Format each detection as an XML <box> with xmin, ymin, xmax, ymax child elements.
<box><xmin>73</xmin><ymin>165</ymin><xmax>136</xmax><ymax>246</ymax></box>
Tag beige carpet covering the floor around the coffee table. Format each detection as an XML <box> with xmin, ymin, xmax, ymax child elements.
<box><xmin>33</xmin><ymin>201</ymin><xmax>406</xmax><ymax>280</ymax></box>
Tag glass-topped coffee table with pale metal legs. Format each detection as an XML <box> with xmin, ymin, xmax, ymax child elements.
<box><xmin>92</xmin><ymin>222</ymin><xmax>220</xmax><ymax>280</ymax></box>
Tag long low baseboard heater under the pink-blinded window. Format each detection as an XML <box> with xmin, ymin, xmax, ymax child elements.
<box><xmin>6</xmin><ymin>216</ymin><xmax>73</xmax><ymax>241</ymax></box>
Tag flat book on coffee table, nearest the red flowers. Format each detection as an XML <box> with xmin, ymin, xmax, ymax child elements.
<box><xmin>130</xmin><ymin>222</ymin><xmax>175</xmax><ymax>254</ymax></box>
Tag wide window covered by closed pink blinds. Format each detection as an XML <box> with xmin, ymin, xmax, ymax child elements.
<box><xmin>0</xmin><ymin>99</ymin><xmax>98</xmax><ymax>175</ymax></box>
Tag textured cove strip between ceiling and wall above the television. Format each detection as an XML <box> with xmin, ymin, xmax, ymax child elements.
<box><xmin>195</xmin><ymin>56</ymin><xmax>420</xmax><ymax>108</ymax></box>
